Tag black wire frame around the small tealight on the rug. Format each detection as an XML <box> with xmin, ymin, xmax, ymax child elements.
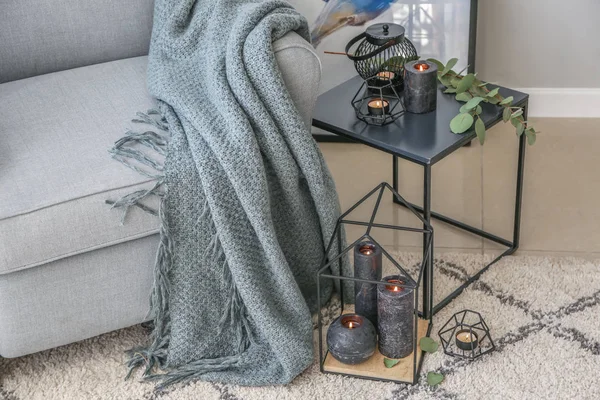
<box><xmin>438</xmin><ymin>310</ymin><xmax>496</xmax><ymax>360</ymax></box>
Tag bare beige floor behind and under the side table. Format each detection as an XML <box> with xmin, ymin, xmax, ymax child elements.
<box><xmin>321</xmin><ymin>118</ymin><xmax>600</xmax><ymax>258</ymax></box>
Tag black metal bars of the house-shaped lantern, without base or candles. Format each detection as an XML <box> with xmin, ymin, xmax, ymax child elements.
<box><xmin>317</xmin><ymin>182</ymin><xmax>433</xmax><ymax>385</ymax></box>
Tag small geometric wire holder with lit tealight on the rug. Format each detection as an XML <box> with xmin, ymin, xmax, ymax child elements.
<box><xmin>438</xmin><ymin>310</ymin><xmax>496</xmax><ymax>360</ymax></box>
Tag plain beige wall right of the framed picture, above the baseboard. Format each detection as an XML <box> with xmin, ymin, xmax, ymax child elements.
<box><xmin>476</xmin><ymin>0</ymin><xmax>600</xmax><ymax>88</ymax></box>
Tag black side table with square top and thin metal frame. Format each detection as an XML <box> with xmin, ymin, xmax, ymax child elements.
<box><xmin>313</xmin><ymin>76</ymin><xmax>529</xmax><ymax>318</ymax></box>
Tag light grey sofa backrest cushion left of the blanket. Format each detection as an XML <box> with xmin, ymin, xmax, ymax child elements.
<box><xmin>0</xmin><ymin>0</ymin><xmax>154</xmax><ymax>83</ymax></box>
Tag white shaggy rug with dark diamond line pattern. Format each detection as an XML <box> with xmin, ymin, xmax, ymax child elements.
<box><xmin>0</xmin><ymin>254</ymin><xmax>600</xmax><ymax>400</ymax></box>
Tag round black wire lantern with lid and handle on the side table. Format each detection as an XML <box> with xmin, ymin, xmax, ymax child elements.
<box><xmin>346</xmin><ymin>23</ymin><xmax>419</xmax><ymax>94</ymax></box>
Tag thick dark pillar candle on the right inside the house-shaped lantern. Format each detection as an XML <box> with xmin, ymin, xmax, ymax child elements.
<box><xmin>377</xmin><ymin>275</ymin><xmax>415</xmax><ymax>358</ymax></box>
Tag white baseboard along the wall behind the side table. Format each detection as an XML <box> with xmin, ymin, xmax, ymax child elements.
<box><xmin>516</xmin><ymin>88</ymin><xmax>600</xmax><ymax>118</ymax></box>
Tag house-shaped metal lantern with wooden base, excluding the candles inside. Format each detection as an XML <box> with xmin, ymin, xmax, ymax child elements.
<box><xmin>317</xmin><ymin>182</ymin><xmax>433</xmax><ymax>384</ymax></box>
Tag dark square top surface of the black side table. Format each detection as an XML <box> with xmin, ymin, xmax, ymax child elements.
<box><xmin>313</xmin><ymin>76</ymin><xmax>529</xmax><ymax>165</ymax></box>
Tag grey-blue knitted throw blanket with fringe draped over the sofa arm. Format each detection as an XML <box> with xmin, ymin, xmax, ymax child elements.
<box><xmin>106</xmin><ymin>0</ymin><xmax>346</xmax><ymax>385</ymax></box>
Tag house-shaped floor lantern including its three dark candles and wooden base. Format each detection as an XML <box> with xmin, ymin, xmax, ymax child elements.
<box><xmin>317</xmin><ymin>182</ymin><xmax>433</xmax><ymax>384</ymax></box>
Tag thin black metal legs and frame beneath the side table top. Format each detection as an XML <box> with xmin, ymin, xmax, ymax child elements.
<box><xmin>392</xmin><ymin>100</ymin><xmax>529</xmax><ymax>318</ymax></box>
